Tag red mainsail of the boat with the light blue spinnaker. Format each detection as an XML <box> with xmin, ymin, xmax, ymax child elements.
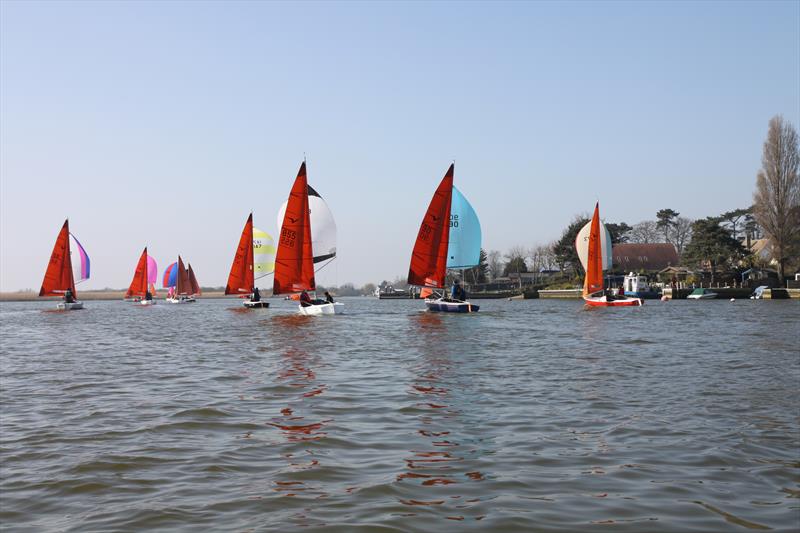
<box><xmin>408</xmin><ymin>165</ymin><xmax>454</xmax><ymax>288</ymax></box>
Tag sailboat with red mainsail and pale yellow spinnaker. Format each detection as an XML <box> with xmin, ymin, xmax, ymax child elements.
<box><xmin>225</xmin><ymin>213</ymin><xmax>275</xmax><ymax>309</ymax></box>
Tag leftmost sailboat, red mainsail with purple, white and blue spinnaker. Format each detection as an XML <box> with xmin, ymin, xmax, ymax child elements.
<box><xmin>39</xmin><ymin>219</ymin><xmax>91</xmax><ymax>311</ymax></box>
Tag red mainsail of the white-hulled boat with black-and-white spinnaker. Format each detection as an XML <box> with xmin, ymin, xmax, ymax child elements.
<box><xmin>272</xmin><ymin>162</ymin><xmax>316</xmax><ymax>294</ymax></box>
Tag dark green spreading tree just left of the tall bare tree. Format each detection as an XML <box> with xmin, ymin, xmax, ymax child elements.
<box><xmin>683</xmin><ymin>217</ymin><xmax>746</xmax><ymax>283</ymax></box>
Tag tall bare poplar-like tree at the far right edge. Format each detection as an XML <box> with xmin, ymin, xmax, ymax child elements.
<box><xmin>753</xmin><ymin>115</ymin><xmax>800</xmax><ymax>284</ymax></box>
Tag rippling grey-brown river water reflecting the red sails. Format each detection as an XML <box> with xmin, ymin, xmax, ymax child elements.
<box><xmin>0</xmin><ymin>298</ymin><xmax>800</xmax><ymax>532</ymax></box>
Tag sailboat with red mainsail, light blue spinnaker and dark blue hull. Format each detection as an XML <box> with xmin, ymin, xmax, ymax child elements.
<box><xmin>408</xmin><ymin>164</ymin><xmax>481</xmax><ymax>313</ymax></box>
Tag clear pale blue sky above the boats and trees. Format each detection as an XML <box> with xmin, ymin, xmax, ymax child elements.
<box><xmin>0</xmin><ymin>0</ymin><xmax>800</xmax><ymax>291</ymax></box>
